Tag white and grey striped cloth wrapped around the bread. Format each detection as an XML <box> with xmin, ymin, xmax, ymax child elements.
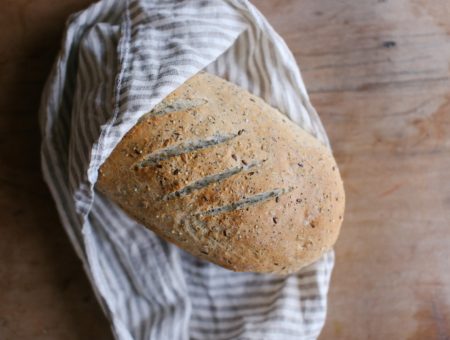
<box><xmin>40</xmin><ymin>0</ymin><xmax>334</xmax><ymax>340</ymax></box>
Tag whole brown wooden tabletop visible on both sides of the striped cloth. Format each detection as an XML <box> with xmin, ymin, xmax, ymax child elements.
<box><xmin>0</xmin><ymin>0</ymin><xmax>450</xmax><ymax>340</ymax></box>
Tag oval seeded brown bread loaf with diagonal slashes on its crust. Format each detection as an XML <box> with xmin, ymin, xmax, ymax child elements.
<box><xmin>97</xmin><ymin>72</ymin><xmax>345</xmax><ymax>273</ymax></box>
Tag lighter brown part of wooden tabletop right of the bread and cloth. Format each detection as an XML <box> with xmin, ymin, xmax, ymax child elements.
<box><xmin>255</xmin><ymin>0</ymin><xmax>450</xmax><ymax>340</ymax></box>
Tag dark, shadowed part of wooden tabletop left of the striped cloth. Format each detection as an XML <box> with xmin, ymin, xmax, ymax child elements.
<box><xmin>0</xmin><ymin>0</ymin><xmax>112</xmax><ymax>340</ymax></box>
